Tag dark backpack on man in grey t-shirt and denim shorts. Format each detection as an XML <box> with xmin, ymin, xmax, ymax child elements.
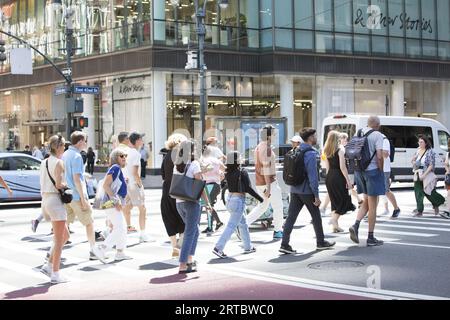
<box><xmin>345</xmin><ymin>130</ymin><xmax>377</xmax><ymax>174</ymax></box>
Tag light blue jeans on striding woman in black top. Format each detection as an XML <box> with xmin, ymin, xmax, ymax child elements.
<box><xmin>216</xmin><ymin>195</ymin><xmax>252</xmax><ymax>251</ymax></box>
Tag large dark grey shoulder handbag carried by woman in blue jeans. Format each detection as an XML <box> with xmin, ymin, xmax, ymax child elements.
<box><xmin>169</xmin><ymin>166</ymin><xmax>206</xmax><ymax>201</ymax></box>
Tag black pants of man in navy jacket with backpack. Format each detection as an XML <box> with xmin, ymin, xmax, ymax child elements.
<box><xmin>281</xmin><ymin>193</ymin><xmax>324</xmax><ymax>246</ymax></box>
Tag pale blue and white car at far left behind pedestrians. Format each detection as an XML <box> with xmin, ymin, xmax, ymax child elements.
<box><xmin>0</xmin><ymin>153</ymin><xmax>97</xmax><ymax>202</ymax></box>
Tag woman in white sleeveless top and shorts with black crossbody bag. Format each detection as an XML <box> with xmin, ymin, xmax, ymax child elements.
<box><xmin>40</xmin><ymin>135</ymin><xmax>69</xmax><ymax>284</ymax></box>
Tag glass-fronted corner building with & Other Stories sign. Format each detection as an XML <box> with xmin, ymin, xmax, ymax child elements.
<box><xmin>0</xmin><ymin>0</ymin><xmax>450</xmax><ymax>168</ymax></box>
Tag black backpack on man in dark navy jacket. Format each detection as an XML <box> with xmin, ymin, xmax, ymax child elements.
<box><xmin>283</xmin><ymin>147</ymin><xmax>314</xmax><ymax>186</ymax></box>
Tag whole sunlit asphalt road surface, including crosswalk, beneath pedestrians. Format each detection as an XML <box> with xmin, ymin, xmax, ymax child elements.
<box><xmin>0</xmin><ymin>186</ymin><xmax>450</xmax><ymax>300</ymax></box>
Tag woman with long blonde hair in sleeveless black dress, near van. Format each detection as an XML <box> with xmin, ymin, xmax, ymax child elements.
<box><xmin>323</xmin><ymin>131</ymin><xmax>356</xmax><ymax>233</ymax></box>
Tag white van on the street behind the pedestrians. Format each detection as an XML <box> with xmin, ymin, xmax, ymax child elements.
<box><xmin>321</xmin><ymin>115</ymin><xmax>450</xmax><ymax>182</ymax></box>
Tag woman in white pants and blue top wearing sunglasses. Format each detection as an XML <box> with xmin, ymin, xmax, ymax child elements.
<box><xmin>98</xmin><ymin>149</ymin><xmax>131</xmax><ymax>262</ymax></box>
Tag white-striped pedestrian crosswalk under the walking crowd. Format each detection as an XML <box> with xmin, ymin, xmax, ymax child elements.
<box><xmin>0</xmin><ymin>197</ymin><xmax>450</xmax><ymax>299</ymax></box>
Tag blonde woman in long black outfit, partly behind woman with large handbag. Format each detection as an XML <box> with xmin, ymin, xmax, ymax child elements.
<box><xmin>161</xmin><ymin>134</ymin><xmax>187</xmax><ymax>258</ymax></box>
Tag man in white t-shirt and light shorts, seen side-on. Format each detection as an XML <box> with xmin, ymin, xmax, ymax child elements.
<box><xmin>123</xmin><ymin>132</ymin><xmax>149</xmax><ymax>242</ymax></box>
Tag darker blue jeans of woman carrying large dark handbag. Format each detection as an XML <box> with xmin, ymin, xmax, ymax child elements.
<box><xmin>177</xmin><ymin>201</ymin><xmax>201</xmax><ymax>263</ymax></box>
